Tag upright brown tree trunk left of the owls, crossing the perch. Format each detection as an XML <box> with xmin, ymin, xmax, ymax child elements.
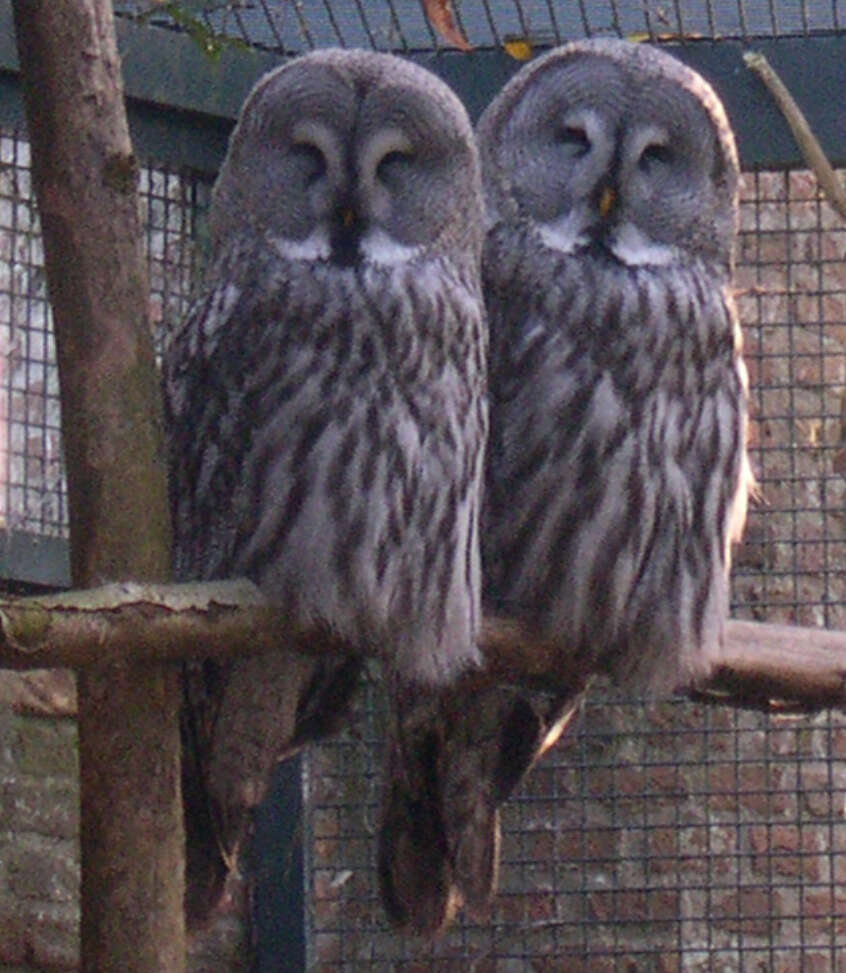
<box><xmin>13</xmin><ymin>0</ymin><xmax>184</xmax><ymax>973</ymax></box>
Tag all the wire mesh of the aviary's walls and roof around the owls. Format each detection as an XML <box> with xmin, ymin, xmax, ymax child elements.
<box><xmin>0</xmin><ymin>13</ymin><xmax>846</xmax><ymax>973</ymax></box>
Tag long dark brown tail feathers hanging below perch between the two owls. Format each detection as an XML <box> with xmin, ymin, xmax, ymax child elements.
<box><xmin>378</xmin><ymin>686</ymin><xmax>574</xmax><ymax>935</ymax></box>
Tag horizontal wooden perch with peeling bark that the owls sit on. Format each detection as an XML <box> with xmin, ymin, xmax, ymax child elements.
<box><xmin>0</xmin><ymin>580</ymin><xmax>846</xmax><ymax>709</ymax></box>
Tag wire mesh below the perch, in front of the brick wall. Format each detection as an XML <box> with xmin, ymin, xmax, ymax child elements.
<box><xmin>306</xmin><ymin>680</ymin><xmax>846</xmax><ymax>973</ymax></box>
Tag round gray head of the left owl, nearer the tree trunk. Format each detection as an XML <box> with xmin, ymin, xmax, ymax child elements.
<box><xmin>211</xmin><ymin>50</ymin><xmax>482</xmax><ymax>266</ymax></box>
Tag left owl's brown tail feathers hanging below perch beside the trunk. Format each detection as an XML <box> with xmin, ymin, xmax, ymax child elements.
<box><xmin>181</xmin><ymin>652</ymin><xmax>362</xmax><ymax>929</ymax></box>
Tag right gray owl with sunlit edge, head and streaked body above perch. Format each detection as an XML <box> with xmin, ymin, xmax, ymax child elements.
<box><xmin>478</xmin><ymin>39</ymin><xmax>751</xmax><ymax>700</ymax></box>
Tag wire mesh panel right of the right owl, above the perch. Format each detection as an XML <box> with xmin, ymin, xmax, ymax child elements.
<box><xmin>735</xmin><ymin>171</ymin><xmax>846</xmax><ymax>628</ymax></box>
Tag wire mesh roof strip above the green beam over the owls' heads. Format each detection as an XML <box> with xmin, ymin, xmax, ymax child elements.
<box><xmin>115</xmin><ymin>0</ymin><xmax>846</xmax><ymax>53</ymax></box>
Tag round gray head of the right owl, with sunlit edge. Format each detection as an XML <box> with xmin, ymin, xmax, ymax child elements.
<box><xmin>478</xmin><ymin>39</ymin><xmax>739</xmax><ymax>267</ymax></box>
